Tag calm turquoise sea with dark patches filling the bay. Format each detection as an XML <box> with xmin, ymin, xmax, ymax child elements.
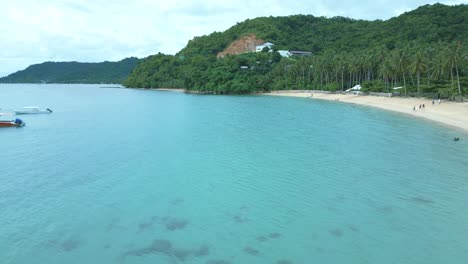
<box><xmin>0</xmin><ymin>84</ymin><xmax>468</xmax><ymax>264</ymax></box>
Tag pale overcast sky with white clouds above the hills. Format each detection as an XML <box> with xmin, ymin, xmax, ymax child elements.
<box><xmin>0</xmin><ymin>0</ymin><xmax>468</xmax><ymax>77</ymax></box>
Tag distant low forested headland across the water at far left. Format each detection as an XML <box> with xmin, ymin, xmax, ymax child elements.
<box><xmin>0</xmin><ymin>58</ymin><xmax>140</xmax><ymax>83</ymax></box>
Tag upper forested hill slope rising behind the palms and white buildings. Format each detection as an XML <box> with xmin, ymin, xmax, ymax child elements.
<box><xmin>179</xmin><ymin>4</ymin><xmax>468</xmax><ymax>55</ymax></box>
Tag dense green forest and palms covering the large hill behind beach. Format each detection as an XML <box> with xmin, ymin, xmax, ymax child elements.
<box><xmin>124</xmin><ymin>4</ymin><xmax>468</xmax><ymax>98</ymax></box>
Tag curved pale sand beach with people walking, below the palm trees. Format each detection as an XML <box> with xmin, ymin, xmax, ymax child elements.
<box><xmin>263</xmin><ymin>91</ymin><xmax>468</xmax><ymax>133</ymax></box>
